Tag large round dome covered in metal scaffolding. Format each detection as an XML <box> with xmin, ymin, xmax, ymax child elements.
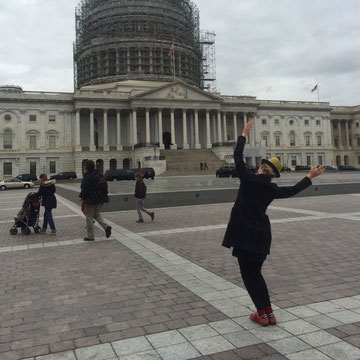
<box><xmin>74</xmin><ymin>0</ymin><xmax>216</xmax><ymax>91</ymax></box>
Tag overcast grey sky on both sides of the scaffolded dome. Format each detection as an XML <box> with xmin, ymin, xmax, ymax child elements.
<box><xmin>0</xmin><ymin>0</ymin><xmax>360</xmax><ymax>105</ymax></box>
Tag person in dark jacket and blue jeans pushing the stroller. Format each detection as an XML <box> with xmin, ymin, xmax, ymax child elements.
<box><xmin>37</xmin><ymin>174</ymin><xmax>57</xmax><ymax>235</ymax></box>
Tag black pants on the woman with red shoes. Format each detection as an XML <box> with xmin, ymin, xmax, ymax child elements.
<box><xmin>238</xmin><ymin>258</ymin><xmax>271</xmax><ymax>310</ymax></box>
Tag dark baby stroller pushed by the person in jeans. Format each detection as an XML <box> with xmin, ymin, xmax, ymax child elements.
<box><xmin>10</xmin><ymin>193</ymin><xmax>41</xmax><ymax>235</ymax></box>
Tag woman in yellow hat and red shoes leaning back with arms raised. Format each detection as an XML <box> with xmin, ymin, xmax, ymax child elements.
<box><xmin>222</xmin><ymin>121</ymin><xmax>325</xmax><ymax>326</ymax></box>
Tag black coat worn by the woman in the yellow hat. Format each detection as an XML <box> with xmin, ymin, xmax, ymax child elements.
<box><xmin>222</xmin><ymin>136</ymin><xmax>311</xmax><ymax>254</ymax></box>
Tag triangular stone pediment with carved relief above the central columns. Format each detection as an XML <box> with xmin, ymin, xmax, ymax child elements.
<box><xmin>132</xmin><ymin>81</ymin><xmax>222</xmax><ymax>102</ymax></box>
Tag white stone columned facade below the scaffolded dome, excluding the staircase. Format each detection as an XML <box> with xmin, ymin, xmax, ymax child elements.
<box><xmin>0</xmin><ymin>81</ymin><xmax>360</xmax><ymax>178</ymax></box>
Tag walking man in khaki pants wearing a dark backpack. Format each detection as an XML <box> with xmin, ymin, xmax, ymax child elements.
<box><xmin>79</xmin><ymin>160</ymin><xmax>111</xmax><ymax>241</ymax></box>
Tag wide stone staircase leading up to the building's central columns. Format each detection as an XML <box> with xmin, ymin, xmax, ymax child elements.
<box><xmin>160</xmin><ymin>149</ymin><xmax>225</xmax><ymax>176</ymax></box>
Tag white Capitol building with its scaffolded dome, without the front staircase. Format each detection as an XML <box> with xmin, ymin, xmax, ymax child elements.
<box><xmin>0</xmin><ymin>0</ymin><xmax>360</xmax><ymax>178</ymax></box>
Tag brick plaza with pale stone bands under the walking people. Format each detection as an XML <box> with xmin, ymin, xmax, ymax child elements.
<box><xmin>0</xmin><ymin>190</ymin><xmax>360</xmax><ymax>360</ymax></box>
